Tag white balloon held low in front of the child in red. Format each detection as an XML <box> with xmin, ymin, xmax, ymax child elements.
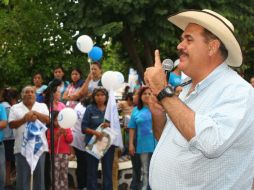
<box><xmin>57</xmin><ymin>108</ymin><xmax>77</xmax><ymax>128</ymax></box>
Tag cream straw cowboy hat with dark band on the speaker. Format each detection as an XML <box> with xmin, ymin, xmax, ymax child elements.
<box><xmin>168</xmin><ymin>9</ymin><xmax>243</xmax><ymax>67</ymax></box>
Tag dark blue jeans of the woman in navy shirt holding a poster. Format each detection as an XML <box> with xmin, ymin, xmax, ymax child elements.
<box><xmin>86</xmin><ymin>145</ymin><xmax>115</xmax><ymax>190</ymax></box>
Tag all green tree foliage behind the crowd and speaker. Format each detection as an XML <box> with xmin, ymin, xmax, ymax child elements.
<box><xmin>0</xmin><ymin>0</ymin><xmax>254</xmax><ymax>87</ymax></box>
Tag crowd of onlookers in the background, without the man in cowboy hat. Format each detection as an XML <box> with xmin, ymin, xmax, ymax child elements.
<box><xmin>0</xmin><ymin>57</ymin><xmax>157</xmax><ymax>190</ymax></box>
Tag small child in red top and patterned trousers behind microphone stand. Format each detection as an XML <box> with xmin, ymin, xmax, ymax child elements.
<box><xmin>47</xmin><ymin>111</ymin><xmax>73</xmax><ymax>190</ymax></box>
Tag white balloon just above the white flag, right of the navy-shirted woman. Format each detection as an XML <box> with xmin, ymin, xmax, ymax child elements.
<box><xmin>101</xmin><ymin>71</ymin><xmax>124</xmax><ymax>90</ymax></box>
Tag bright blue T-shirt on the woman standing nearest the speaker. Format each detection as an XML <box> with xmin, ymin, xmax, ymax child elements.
<box><xmin>128</xmin><ymin>106</ymin><xmax>157</xmax><ymax>153</ymax></box>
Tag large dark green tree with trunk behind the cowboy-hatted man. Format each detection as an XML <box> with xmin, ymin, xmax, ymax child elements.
<box><xmin>50</xmin><ymin>0</ymin><xmax>254</xmax><ymax>80</ymax></box>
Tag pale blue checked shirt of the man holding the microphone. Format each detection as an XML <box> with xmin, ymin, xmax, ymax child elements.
<box><xmin>149</xmin><ymin>63</ymin><xmax>254</xmax><ymax>190</ymax></box>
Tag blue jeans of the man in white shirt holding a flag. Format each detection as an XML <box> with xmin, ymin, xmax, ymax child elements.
<box><xmin>15</xmin><ymin>153</ymin><xmax>45</xmax><ymax>190</ymax></box>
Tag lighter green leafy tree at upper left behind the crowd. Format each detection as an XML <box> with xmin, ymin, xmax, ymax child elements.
<box><xmin>0</xmin><ymin>0</ymin><xmax>89</xmax><ymax>87</ymax></box>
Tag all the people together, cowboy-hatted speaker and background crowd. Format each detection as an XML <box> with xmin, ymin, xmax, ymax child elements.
<box><xmin>0</xmin><ymin>10</ymin><xmax>254</xmax><ymax>190</ymax></box>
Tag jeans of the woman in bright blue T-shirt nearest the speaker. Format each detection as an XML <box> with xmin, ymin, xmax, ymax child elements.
<box><xmin>140</xmin><ymin>153</ymin><xmax>152</xmax><ymax>190</ymax></box>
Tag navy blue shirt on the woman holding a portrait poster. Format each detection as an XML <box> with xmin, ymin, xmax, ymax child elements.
<box><xmin>81</xmin><ymin>104</ymin><xmax>105</xmax><ymax>144</ymax></box>
